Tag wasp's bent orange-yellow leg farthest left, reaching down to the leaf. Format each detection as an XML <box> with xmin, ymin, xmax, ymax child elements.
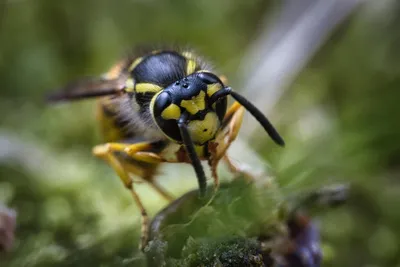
<box><xmin>93</xmin><ymin>143</ymin><xmax>164</xmax><ymax>250</ymax></box>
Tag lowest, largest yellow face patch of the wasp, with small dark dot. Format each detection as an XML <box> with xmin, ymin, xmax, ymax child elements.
<box><xmin>188</xmin><ymin>112</ymin><xmax>220</xmax><ymax>147</ymax></box>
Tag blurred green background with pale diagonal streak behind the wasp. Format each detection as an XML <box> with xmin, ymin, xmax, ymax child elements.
<box><xmin>0</xmin><ymin>0</ymin><xmax>400</xmax><ymax>267</ymax></box>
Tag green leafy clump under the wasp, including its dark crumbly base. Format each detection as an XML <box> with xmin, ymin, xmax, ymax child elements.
<box><xmin>145</xmin><ymin>178</ymin><xmax>284</xmax><ymax>266</ymax></box>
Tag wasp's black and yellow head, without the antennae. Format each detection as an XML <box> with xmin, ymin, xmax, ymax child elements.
<box><xmin>151</xmin><ymin>72</ymin><xmax>226</xmax><ymax>144</ymax></box>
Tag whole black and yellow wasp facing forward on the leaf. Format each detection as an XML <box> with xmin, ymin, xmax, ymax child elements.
<box><xmin>48</xmin><ymin>49</ymin><xmax>284</xmax><ymax>251</ymax></box>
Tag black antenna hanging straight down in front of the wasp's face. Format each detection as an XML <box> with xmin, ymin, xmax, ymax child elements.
<box><xmin>178</xmin><ymin>112</ymin><xmax>207</xmax><ymax>197</ymax></box>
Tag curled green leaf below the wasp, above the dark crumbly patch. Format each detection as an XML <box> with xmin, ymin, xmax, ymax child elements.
<box><xmin>145</xmin><ymin>179</ymin><xmax>282</xmax><ymax>258</ymax></box>
